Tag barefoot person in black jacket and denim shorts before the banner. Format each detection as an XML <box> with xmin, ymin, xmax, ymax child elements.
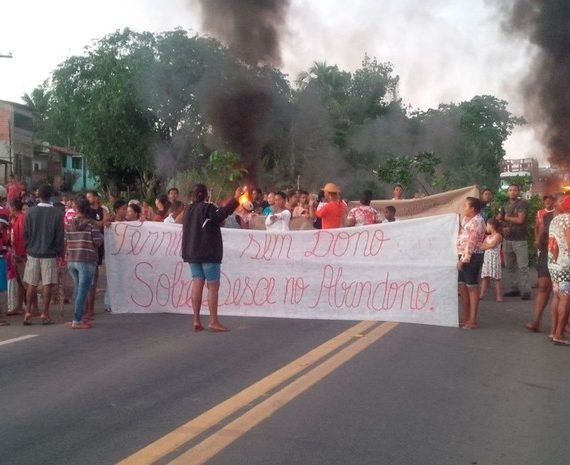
<box><xmin>182</xmin><ymin>184</ymin><xmax>242</xmax><ymax>331</ymax></box>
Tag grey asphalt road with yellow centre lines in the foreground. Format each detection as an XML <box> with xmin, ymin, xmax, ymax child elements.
<box><xmin>0</xmin><ymin>290</ymin><xmax>570</xmax><ymax>465</ymax></box>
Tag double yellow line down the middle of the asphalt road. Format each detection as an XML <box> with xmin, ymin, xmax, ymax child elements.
<box><xmin>117</xmin><ymin>321</ymin><xmax>398</xmax><ymax>465</ymax></box>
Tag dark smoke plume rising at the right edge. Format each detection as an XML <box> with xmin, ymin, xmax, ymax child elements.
<box><xmin>505</xmin><ymin>0</ymin><xmax>570</xmax><ymax>167</ymax></box>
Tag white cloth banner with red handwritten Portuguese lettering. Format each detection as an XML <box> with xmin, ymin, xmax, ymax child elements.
<box><xmin>105</xmin><ymin>214</ymin><xmax>458</xmax><ymax>326</ymax></box>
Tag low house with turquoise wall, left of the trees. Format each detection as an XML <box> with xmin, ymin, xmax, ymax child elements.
<box><xmin>32</xmin><ymin>142</ymin><xmax>98</xmax><ymax>192</ymax></box>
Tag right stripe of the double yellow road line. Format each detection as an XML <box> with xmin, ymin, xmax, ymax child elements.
<box><xmin>168</xmin><ymin>323</ymin><xmax>398</xmax><ymax>465</ymax></box>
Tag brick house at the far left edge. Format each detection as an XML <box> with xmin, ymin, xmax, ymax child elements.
<box><xmin>0</xmin><ymin>100</ymin><xmax>34</xmax><ymax>185</ymax></box>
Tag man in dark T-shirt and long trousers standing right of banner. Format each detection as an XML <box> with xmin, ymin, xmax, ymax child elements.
<box><xmin>497</xmin><ymin>184</ymin><xmax>531</xmax><ymax>300</ymax></box>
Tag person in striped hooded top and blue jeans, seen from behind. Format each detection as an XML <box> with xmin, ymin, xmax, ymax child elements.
<box><xmin>65</xmin><ymin>199</ymin><xmax>103</xmax><ymax>329</ymax></box>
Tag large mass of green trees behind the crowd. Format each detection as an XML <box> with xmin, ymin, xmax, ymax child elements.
<box><xmin>24</xmin><ymin>29</ymin><xmax>523</xmax><ymax>197</ymax></box>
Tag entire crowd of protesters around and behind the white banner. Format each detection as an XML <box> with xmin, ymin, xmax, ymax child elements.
<box><xmin>0</xmin><ymin>177</ymin><xmax>570</xmax><ymax>345</ymax></box>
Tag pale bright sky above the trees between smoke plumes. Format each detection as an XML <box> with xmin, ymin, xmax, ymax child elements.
<box><xmin>0</xmin><ymin>0</ymin><xmax>546</xmax><ymax>163</ymax></box>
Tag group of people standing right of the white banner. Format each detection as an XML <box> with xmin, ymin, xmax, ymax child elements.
<box><xmin>457</xmin><ymin>184</ymin><xmax>570</xmax><ymax>346</ymax></box>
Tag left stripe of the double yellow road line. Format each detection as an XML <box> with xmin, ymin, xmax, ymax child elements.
<box><xmin>117</xmin><ymin>321</ymin><xmax>378</xmax><ymax>465</ymax></box>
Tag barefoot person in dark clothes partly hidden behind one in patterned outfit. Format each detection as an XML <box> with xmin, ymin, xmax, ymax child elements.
<box><xmin>525</xmin><ymin>195</ymin><xmax>562</xmax><ymax>333</ymax></box>
